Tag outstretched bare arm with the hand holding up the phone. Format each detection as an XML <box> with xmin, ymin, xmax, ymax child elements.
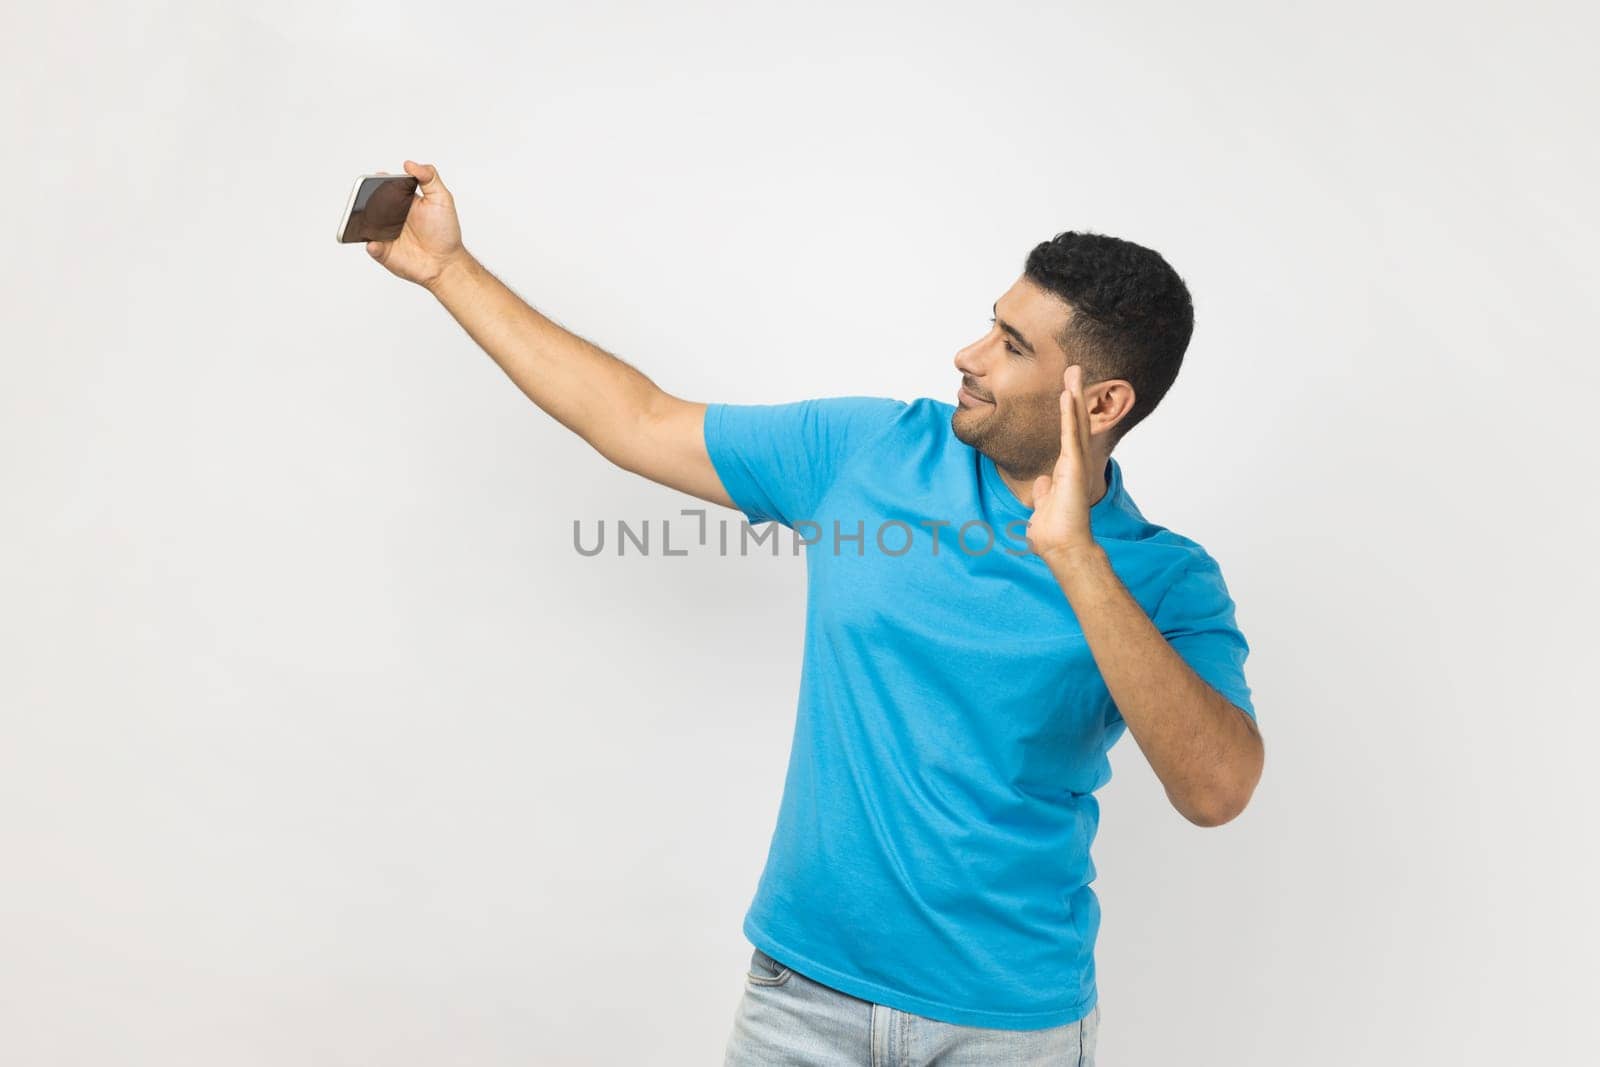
<box><xmin>366</xmin><ymin>160</ymin><xmax>734</xmax><ymax>507</ymax></box>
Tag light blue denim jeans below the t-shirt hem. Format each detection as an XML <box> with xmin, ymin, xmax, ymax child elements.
<box><xmin>723</xmin><ymin>949</ymin><xmax>1099</xmax><ymax>1067</ymax></box>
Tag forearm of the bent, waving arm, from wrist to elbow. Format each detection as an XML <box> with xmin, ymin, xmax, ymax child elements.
<box><xmin>1048</xmin><ymin>545</ymin><xmax>1262</xmax><ymax>825</ymax></box>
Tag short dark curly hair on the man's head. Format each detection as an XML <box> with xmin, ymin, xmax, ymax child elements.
<box><xmin>1022</xmin><ymin>230</ymin><xmax>1195</xmax><ymax>445</ymax></box>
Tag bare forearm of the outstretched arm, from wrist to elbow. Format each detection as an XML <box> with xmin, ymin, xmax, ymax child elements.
<box><xmin>427</xmin><ymin>250</ymin><xmax>661</xmax><ymax>467</ymax></box>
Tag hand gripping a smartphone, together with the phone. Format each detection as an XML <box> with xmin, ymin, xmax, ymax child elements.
<box><xmin>338</xmin><ymin>160</ymin><xmax>467</xmax><ymax>286</ymax></box>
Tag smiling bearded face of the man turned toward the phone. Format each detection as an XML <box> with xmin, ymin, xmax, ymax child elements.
<box><xmin>950</xmin><ymin>277</ymin><xmax>1072</xmax><ymax>475</ymax></box>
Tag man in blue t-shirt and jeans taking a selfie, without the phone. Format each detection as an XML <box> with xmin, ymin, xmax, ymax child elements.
<box><xmin>366</xmin><ymin>160</ymin><xmax>1262</xmax><ymax>1064</ymax></box>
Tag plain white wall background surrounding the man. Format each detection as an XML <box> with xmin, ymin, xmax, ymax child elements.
<box><xmin>0</xmin><ymin>0</ymin><xmax>1600</xmax><ymax>1067</ymax></box>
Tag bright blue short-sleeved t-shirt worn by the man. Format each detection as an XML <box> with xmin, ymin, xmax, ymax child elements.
<box><xmin>704</xmin><ymin>397</ymin><xmax>1254</xmax><ymax>1030</ymax></box>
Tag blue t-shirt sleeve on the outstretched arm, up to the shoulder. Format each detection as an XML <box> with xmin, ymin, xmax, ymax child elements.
<box><xmin>704</xmin><ymin>397</ymin><xmax>909</xmax><ymax>528</ymax></box>
